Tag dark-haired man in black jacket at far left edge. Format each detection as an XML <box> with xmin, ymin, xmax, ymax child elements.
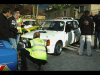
<box><xmin>0</xmin><ymin>8</ymin><xmax>10</xmax><ymax>41</ymax></box>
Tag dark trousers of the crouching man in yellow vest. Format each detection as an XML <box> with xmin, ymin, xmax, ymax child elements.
<box><xmin>21</xmin><ymin>48</ymin><xmax>47</xmax><ymax>68</ymax></box>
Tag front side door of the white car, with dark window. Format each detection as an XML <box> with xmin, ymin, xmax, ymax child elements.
<box><xmin>65</xmin><ymin>21</ymin><xmax>74</xmax><ymax>46</ymax></box>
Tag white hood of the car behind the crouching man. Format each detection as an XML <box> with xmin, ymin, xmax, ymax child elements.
<box><xmin>21</xmin><ymin>30</ymin><xmax>62</xmax><ymax>39</ymax></box>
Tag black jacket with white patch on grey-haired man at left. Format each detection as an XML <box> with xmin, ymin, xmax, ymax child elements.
<box><xmin>8</xmin><ymin>16</ymin><xmax>18</xmax><ymax>39</ymax></box>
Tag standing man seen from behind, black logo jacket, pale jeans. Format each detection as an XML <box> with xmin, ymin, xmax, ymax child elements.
<box><xmin>78</xmin><ymin>10</ymin><xmax>94</xmax><ymax>56</ymax></box>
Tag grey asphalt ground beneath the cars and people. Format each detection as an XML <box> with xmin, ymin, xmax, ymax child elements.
<box><xmin>19</xmin><ymin>36</ymin><xmax>100</xmax><ymax>71</ymax></box>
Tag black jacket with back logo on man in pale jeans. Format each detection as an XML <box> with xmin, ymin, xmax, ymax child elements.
<box><xmin>79</xmin><ymin>15</ymin><xmax>94</xmax><ymax>35</ymax></box>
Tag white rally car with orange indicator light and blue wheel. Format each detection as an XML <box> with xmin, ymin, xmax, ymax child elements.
<box><xmin>21</xmin><ymin>19</ymin><xmax>81</xmax><ymax>55</ymax></box>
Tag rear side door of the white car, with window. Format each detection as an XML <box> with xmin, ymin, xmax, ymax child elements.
<box><xmin>73</xmin><ymin>20</ymin><xmax>81</xmax><ymax>42</ymax></box>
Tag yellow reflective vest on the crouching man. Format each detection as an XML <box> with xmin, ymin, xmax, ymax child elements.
<box><xmin>26</xmin><ymin>38</ymin><xmax>47</xmax><ymax>61</ymax></box>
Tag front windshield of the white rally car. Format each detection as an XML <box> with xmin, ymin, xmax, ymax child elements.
<box><xmin>41</xmin><ymin>21</ymin><xmax>65</xmax><ymax>31</ymax></box>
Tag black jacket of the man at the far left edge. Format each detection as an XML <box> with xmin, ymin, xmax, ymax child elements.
<box><xmin>0</xmin><ymin>13</ymin><xmax>9</xmax><ymax>41</ymax></box>
